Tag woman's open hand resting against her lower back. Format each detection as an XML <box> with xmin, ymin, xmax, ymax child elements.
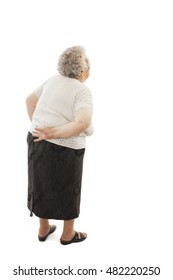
<box><xmin>32</xmin><ymin>127</ymin><xmax>58</xmax><ymax>142</ymax></box>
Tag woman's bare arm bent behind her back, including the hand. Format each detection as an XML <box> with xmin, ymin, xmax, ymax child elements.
<box><xmin>32</xmin><ymin>109</ymin><xmax>92</xmax><ymax>142</ymax></box>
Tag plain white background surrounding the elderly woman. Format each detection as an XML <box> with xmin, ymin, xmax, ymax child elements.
<box><xmin>0</xmin><ymin>0</ymin><xmax>173</xmax><ymax>280</ymax></box>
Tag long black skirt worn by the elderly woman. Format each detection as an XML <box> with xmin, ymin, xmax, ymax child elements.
<box><xmin>27</xmin><ymin>132</ymin><xmax>85</xmax><ymax>220</ymax></box>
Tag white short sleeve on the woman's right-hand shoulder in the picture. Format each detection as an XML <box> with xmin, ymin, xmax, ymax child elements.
<box><xmin>75</xmin><ymin>88</ymin><xmax>93</xmax><ymax>113</ymax></box>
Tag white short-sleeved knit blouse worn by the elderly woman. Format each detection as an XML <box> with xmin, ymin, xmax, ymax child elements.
<box><xmin>30</xmin><ymin>75</ymin><xmax>93</xmax><ymax>149</ymax></box>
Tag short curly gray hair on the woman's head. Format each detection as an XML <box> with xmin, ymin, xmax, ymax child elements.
<box><xmin>57</xmin><ymin>46</ymin><xmax>86</xmax><ymax>79</ymax></box>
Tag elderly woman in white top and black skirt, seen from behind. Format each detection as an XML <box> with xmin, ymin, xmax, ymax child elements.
<box><xmin>26</xmin><ymin>46</ymin><xmax>93</xmax><ymax>245</ymax></box>
